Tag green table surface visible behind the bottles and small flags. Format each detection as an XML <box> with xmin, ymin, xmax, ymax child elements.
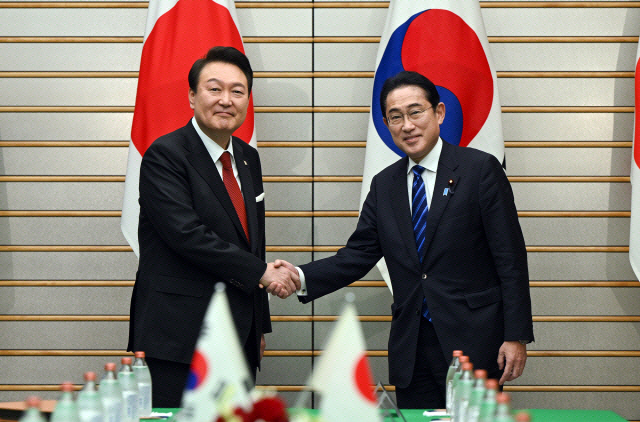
<box><xmin>153</xmin><ymin>409</ymin><xmax>627</xmax><ymax>422</ymax></box>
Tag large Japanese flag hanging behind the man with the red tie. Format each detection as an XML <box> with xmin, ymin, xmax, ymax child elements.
<box><xmin>120</xmin><ymin>0</ymin><xmax>256</xmax><ymax>255</ymax></box>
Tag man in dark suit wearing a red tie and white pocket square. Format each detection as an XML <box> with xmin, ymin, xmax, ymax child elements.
<box><xmin>128</xmin><ymin>47</ymin><xmax>299</xmax><ymax>407</ymax></box>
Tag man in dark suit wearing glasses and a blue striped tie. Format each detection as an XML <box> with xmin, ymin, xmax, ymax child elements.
<box><xmin>276</xmin><ymin>72</ymin><xmax>533</xmax><ymax>408</ymax></box>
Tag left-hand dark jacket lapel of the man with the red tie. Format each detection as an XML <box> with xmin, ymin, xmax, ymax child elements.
<box><xmin>187</xmin><ymin>122</ymin><xmax>253</xmax><ymax>245</ymax></box>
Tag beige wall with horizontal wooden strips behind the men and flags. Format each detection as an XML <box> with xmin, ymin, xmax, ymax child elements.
<box><xmin>0</xmin><ymin>1</ymin><xmax>640</xmax><ymax>420</ymax></box>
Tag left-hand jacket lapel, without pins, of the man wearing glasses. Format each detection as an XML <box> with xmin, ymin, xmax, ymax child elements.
<box><xmin>391</xmin><ymin>157</ymin><xmax>420</xmax><ymax>265</ymax></box>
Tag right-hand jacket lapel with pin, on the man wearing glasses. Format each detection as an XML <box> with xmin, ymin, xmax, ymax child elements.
<box><xmin>424</xmin><ymin>141</ymin><xmax>460</xmax><ymax>262</ymax></box>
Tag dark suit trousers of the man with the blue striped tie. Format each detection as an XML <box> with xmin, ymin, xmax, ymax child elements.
<box><xmin>396</xmin><ymin>318</ymin><xmax>449</xmax><ymax>409</ymax></box>
